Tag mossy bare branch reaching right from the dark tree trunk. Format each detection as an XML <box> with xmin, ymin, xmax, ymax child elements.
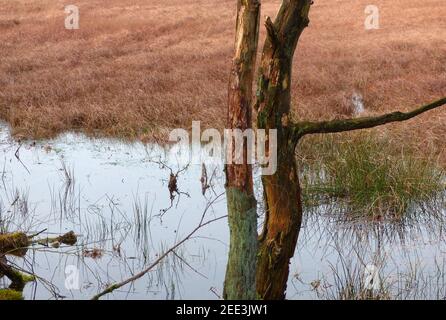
<box><xmin>293</xmin><ymin>98</ymin><xmax>446</xmax><ymax>142</ymax></box>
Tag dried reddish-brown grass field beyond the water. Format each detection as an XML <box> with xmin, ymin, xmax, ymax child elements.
<box><xmin>0</xmin><ymin>0</ymin><xmax>446</xmax><ymax>156</ymax></box>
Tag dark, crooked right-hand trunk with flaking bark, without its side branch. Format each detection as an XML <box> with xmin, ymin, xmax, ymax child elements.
<box><xmin>256</xmin><ymin>0</ymin><xmax>311</xmax><ymax>300</ymax></box>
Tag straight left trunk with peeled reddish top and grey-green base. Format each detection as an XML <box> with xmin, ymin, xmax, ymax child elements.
<box><xmin>223</xmin><ymin>0</ymin><xmax>260</xmax><ymax>300</ymax></box>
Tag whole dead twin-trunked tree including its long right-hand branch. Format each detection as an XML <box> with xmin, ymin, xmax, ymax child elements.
<box><xmin>224</xmin><ymin>0</ymin><xmax>446</xmax><ymax>300</ymax></box>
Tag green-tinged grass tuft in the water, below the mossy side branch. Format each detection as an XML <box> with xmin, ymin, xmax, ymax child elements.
<box><xmin>299</xmin><ymin>132</ymin><xmax>446</xmax><ymax>220</ymax></box>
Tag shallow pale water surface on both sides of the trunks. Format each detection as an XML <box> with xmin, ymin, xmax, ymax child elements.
<box><xmin>0</xmin><ymin>126</ymin><xmax>446</xmax><ymax>299</ymax></box>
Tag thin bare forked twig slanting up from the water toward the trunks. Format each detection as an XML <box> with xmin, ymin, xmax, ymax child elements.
<box><xmin>91</xmin><ymin>194</ymin><xmax>227</xmax><ymax>300</ymax></box>
